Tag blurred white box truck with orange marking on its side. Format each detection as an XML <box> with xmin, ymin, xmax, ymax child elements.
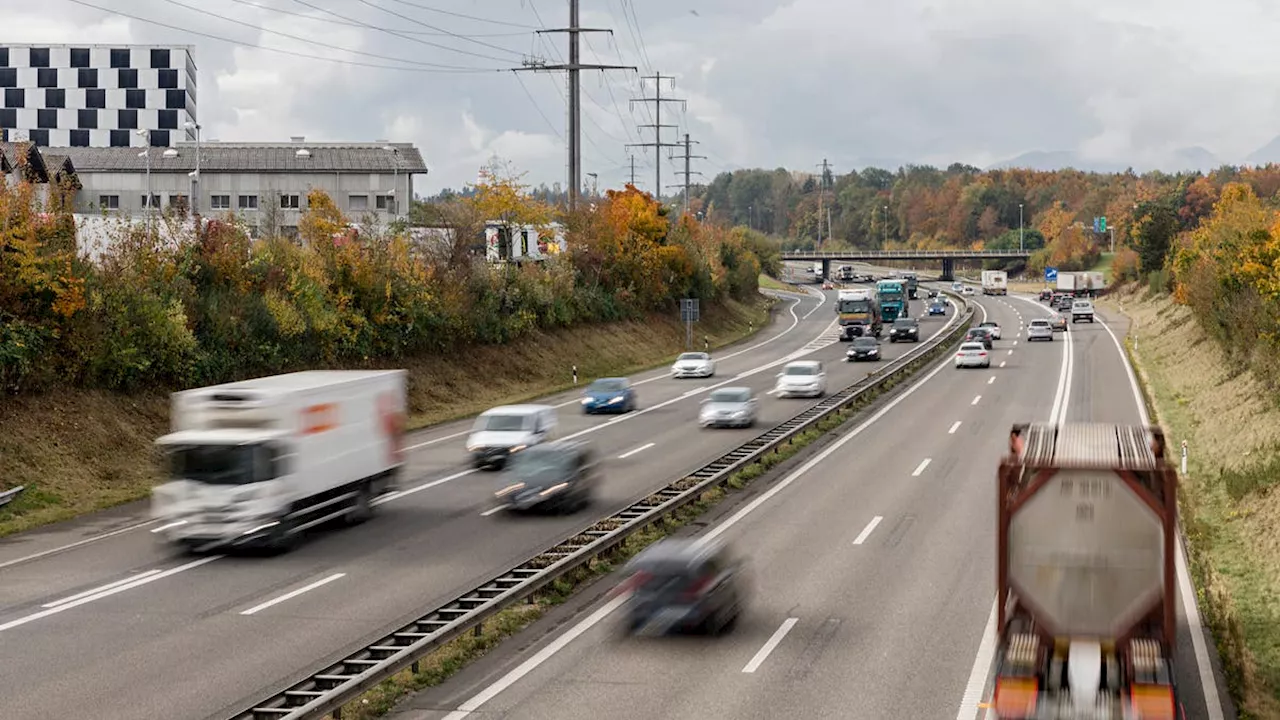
<box><xmin>151</xmin><ymin>370</ymin><xmax>406</xmax><ymax>552</ymax></box>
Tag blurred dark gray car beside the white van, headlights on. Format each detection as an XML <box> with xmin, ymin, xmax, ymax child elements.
<box><xmin>494</xmin><ymin>441</ymin><xmax>599</xmax><ymax>512</ymax></box>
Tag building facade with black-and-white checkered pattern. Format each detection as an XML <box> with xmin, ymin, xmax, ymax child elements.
<box><xmin>0</xmin><ymin>45</ymin><xmax>197</xmax><ymax>147</ymax></box>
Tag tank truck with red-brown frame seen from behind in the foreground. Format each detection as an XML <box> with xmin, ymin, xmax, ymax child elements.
<box><xmin>988</xmin><ymin>423</ymin><xmax>1181</xmax><ymax>720</ymax></box>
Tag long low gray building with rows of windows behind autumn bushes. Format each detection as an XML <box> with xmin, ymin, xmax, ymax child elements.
<box><xmin>58</xmin><ymin>137</ymin><xmax>428</xmax><ymax>232</ymax></box>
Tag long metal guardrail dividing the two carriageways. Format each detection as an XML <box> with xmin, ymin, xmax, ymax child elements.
<box><xmin>230</xmin><ymin>292</ymin><xmax>974</xmax><ymax>720</ymax></box>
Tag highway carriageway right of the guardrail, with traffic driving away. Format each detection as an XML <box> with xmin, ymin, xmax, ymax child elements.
<box><xmin>393</xmin><ymin>286</ymin><xmax>1234</xmax><ymax>720</ymax></box>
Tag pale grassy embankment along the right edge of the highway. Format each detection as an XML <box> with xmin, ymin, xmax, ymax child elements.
<box><xmin>1108</xmin><ymin>286</ymin><xmax>1280</xmax><ymax>719</ymax></box>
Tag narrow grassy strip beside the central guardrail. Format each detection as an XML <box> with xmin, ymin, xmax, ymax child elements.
<box><xmin>317</xmin><ymin>311</ymin><xmax>962</xmax><ymax>720</ymax></box>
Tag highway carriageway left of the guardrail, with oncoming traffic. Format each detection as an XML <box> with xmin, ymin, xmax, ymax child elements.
<box><xmin>0</xmin><ymin>283</ymin><xmax>954</xmax><ymax>720</ymax></box>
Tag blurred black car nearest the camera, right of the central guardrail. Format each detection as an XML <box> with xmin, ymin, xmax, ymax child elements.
<box><xmin>616</xmin><ymin>538</ymin><xmax>744</xmax><ymax>635</ymax></box>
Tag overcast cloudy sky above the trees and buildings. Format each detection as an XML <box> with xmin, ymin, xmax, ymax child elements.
<box><xmin>0</xmin><ymin>0</ymin><xmax>1280</xmax><ymax>193</ymax></box>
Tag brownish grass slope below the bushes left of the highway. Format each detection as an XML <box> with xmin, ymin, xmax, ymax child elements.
<box><xmin>0</xmin><ymin>299</ymin><xmax>768</xmax><ymax>537</ymax></box>
